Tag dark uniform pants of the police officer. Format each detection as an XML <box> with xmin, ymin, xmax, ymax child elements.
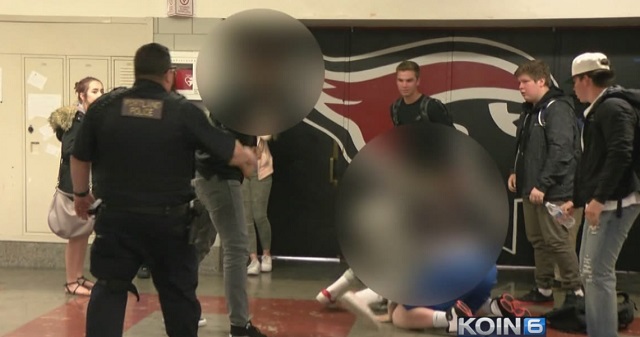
<box><xmin>86</xmin><ymin>205</ymin><xmax>201</xmax><ymax>337</ymax></box>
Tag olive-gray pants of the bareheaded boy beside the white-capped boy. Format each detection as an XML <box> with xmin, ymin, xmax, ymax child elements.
<box><xmin>522</xmin><ymin>198</ymin><xmax>582</xmax><ymax>290</ymax></box>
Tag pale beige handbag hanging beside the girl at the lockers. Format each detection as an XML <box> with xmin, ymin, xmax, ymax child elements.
<box><xmin>48</xmin><ymin>188</ymin><xmax>94</xmax><ymax>239</ymax></box>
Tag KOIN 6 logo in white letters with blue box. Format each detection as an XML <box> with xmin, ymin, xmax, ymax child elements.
<box><xmin>458</xmin><ymin>317</ymin><xmax>547</xmax><ymax>336</ymax></box>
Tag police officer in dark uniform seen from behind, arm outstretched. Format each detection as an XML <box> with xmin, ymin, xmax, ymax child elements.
<box><xmin>71</xmin><ymin>43</ymin><xmax>256</xmax><ymax>337</ymax></box>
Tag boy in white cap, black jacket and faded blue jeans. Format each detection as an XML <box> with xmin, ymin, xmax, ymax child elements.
<box><xmin>563</xmin><ymin>53</ymin><xmax>640</xmax><ymax>337</ymax></box>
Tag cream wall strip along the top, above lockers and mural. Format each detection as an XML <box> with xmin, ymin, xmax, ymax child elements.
<box><xmin>0</xmin><ymin>0</ymin><xmax>640</xmax><ymax>21</ymax></box>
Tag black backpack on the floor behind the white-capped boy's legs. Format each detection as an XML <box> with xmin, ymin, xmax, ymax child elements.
<box><xmin>544</xmin><ymin>292</ymin><xmax>638</xmax><ymax>333</ymax></box>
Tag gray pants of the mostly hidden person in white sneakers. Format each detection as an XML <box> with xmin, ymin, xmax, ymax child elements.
<box><xmin>242</xmin><ymin>174</ymin><xmax>272</xmax><ymax>254</ymax></box>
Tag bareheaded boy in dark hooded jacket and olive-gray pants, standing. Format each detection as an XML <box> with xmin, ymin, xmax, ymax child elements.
<box><xmin>508</xmin><ymin>60</ymin><xmax>584</xmax><ymax>303</ymax></box>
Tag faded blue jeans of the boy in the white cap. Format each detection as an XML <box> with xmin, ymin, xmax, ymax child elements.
<box><xmin>580</xmin><ymin>205</ymin><xmax>640</xmax><ymax>337</ymax></box>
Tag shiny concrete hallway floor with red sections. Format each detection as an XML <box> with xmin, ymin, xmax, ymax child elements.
<box><xmin>0</xmin><ymin>260</ymin><xmax>640</xmax><ymax>337</ymax></box>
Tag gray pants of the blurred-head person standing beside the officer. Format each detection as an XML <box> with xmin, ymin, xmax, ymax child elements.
<box><xmin>194</xmin><ymin>173</ymin><xmax>249</xmax><ymax>327</ymax></box>
